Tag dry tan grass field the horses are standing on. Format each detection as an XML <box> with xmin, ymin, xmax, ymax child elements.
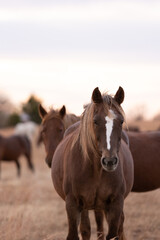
<box><xmin>0</xmin><ymin>123</ymin><xmax>160</xmax><ymax>240</ymax></box>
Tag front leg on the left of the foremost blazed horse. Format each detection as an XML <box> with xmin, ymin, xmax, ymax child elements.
<box><xmin>65</xmin><ymin>196</ymin><xmax>80</xmax><ymax>240</ymax></box>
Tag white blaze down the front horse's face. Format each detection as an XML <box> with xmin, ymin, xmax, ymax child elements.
<box><xmin>105</xmin><ymin>110</ymin><xmax>116</xmax><ymax>150</ymax></box>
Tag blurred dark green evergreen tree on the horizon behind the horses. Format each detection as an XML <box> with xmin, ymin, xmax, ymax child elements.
<box><xmin>22</xmin><ymin>95</ymin><xmax>41</xmax><ymax>124</ymax></box>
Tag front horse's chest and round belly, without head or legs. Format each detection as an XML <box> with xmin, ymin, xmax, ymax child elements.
<box><xmin>52</xmin><ymin>135</ymin><xmax>133</xmax><ymax>210</ymax></box>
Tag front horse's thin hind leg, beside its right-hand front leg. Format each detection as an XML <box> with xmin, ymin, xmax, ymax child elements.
<box><xmin>94</xmin><ymin>210</ymin><xmax>104</xmax><ymax>240</ymax></box>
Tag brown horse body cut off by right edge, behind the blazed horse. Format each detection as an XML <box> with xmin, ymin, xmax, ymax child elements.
<box><xmin>127</xmin><ymin>131</ymin><xmax>160</xmax><ymax>192</ymax></box>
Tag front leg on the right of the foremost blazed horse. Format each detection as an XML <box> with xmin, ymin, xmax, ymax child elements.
<box><xmin>105</xmin><ymin>198</ymin><xmax>124</xmax><ymax>240</ymax></box>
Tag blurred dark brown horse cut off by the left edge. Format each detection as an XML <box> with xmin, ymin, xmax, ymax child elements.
<box><xmin>0</xmin><ymin>135</ymin><xmax>34</xmax><ymax>176</ymax></box>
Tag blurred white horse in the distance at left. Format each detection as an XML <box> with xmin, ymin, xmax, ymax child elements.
<box><xmin>14</xmin><ymin>121</ymin><xmax>37</xmax><ymax>142</ymax></box>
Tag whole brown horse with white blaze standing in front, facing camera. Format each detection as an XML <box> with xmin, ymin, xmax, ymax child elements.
<box><xmin>51</xmin><ymin>87</ymin><xmax>133</xmax><ymax>240</ymax></box>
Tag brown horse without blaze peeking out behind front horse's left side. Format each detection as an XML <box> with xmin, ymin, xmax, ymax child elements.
<box><xmin>37</xmin><ymin>104</ymin><xmax>80</xmax><ymax>167</ymax></box>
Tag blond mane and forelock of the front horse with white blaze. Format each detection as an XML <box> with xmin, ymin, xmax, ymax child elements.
<box><xmin>72</xmin><ymin>93</ymin><xmax>125</xmax><ymax>160</ymax></box>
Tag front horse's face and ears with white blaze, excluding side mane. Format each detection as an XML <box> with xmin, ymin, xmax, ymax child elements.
<box><xmin>92</xmin><ymin>87</ymin><xmax>124</xmax><ymax>171</ymax></box>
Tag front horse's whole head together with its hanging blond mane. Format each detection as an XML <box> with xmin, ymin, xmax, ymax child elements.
<box><xmin>79</xmin><ymin>87</ymin><xmax>124</xmax><ymax>171</ymax></box>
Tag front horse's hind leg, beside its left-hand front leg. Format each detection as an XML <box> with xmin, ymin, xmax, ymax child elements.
<box><xmin>80</xmin><ymin>210</ymin><xmax>91</xmax><ymax>240</ymax></box>
